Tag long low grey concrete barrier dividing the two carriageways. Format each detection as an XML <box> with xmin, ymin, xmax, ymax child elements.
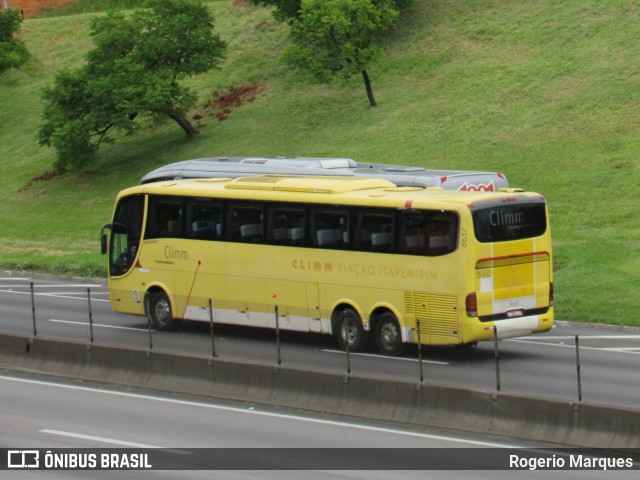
<box><xmin>0</xmin><ymin>335</ymin><xmax>640</xmax><ymax>448</ymax></box>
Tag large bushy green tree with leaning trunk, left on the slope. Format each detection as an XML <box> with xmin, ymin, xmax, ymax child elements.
<box><xmin>38</xmin><ymin>0</ymin><xmax>226</xmax><ymax>171</ymax></box>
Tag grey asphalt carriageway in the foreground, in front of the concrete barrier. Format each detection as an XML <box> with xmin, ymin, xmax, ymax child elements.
<box><xmin>0</xmin><ymin>373</ymin><xmax>637</xmax><ymax>480</ymax></box>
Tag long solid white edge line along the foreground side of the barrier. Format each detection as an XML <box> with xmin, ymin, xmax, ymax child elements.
<box><xmin>0</xmin><ymin>375</ymin><xmax>521</xmax><ymax>448</ymax></box>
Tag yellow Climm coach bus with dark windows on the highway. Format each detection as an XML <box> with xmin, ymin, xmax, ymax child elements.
<box><xmin>102</xmin><ymin>175</ymin><xmax>553</xmax><ymax>355</ymax></box>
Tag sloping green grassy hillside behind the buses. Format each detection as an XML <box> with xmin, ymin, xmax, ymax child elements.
<box><xmin>0</xmin><ymin>0</ymin><xmax>640</xmax><ymax>325</ymax></box>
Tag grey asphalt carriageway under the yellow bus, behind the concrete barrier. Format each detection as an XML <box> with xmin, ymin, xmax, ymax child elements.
<box><xmin>0</xmin><ymin>272</ymin><xmax>640</xmax><ymax>408</ymax></box>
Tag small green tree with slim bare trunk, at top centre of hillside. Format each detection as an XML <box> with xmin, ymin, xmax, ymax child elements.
<box><xmin>285</xmin><ymin>0</ymin><xmax>398</xmax><ymax>107</ymax></box>
